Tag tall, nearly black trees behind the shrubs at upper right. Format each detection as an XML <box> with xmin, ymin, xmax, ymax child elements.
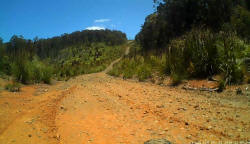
<box><xmin>136</xmin><ymin>0</ymin><xmax>244</xmax><ymax>53</ymax></box>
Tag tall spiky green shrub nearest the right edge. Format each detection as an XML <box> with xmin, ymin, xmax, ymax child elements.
<box><xmin>217</xmin><ymin>32</ymin><xmax>247</xmax><ymax>85</ymax></box>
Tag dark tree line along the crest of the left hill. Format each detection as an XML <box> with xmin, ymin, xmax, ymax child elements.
<box><xmin>6</xmin><ymin>30</ymin><xmax>127</xmax><ymax>59</ymax></box>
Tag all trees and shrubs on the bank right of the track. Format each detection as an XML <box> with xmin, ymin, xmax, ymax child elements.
<box><xmin>109</xmin><ymin>0</ymin><xmax>250</xmax><ymax>90</ymax></box>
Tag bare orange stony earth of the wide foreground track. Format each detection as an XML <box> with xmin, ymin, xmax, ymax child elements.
<box><xmin>0</xmin><ymin>48</ymin><xmax>250</xmax><ymax>144</ymax></box>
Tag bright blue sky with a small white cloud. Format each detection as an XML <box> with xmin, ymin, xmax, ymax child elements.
<box><xmin>0</xmin><ymin>0</ymin><xmax>153</xmax><ymax>42</ymax></box>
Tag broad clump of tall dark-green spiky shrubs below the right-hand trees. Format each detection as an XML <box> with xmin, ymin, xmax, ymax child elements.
<box><xmin>167</xmin><ymin>29</ymin><xmax>218</xmax><ymax>77</ymax></box>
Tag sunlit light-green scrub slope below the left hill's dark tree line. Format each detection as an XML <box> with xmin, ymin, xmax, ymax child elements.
<box><xmin>54</xmin><ymin>43</ymin><xmax>125</xmax><ymax>78</ymax></box>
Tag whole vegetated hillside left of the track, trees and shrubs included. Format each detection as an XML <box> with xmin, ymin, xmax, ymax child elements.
<box><xmin>0</xmin><ymin>30</ymin><xmax>127</xmax><ymax>88</ymax></box>
